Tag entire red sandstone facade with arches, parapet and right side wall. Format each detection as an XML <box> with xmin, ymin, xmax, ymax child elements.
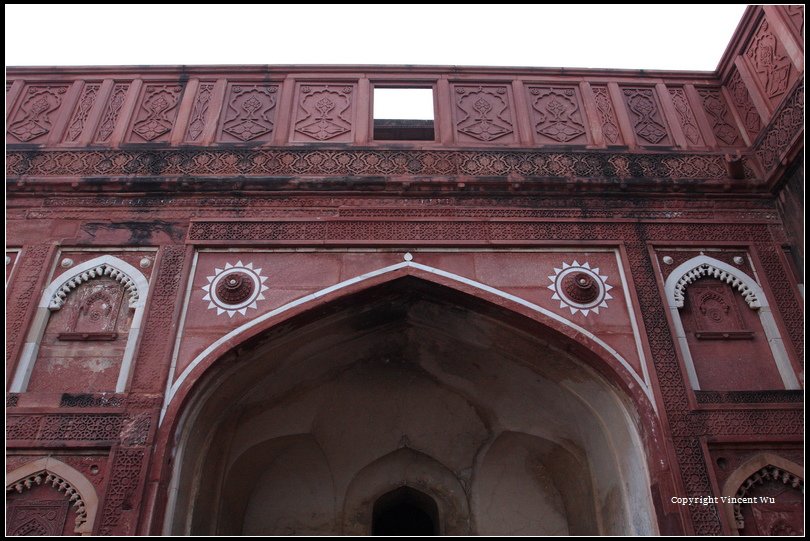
<box><xmin>6</xmin><ymin>6</ymin><xmax>804</xmax><ymax>535</ymax></box>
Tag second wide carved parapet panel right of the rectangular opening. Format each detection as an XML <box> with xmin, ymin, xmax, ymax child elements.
<box><xmin>527</xmin><ymin>85</ymin><xmax>588</xmax><ymax>145</ymax></box>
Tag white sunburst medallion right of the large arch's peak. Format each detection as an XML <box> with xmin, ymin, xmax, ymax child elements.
<box><xmin>548</xmin><ymin>260</ymin><xmax>613</xmax><ymax>316</ymax></box>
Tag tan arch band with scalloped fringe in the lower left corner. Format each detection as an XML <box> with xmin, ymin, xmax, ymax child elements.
<box><xmin>6</xmin><ymin>457</ymin><xmax>98</xmax><ymax>535</ymax></box>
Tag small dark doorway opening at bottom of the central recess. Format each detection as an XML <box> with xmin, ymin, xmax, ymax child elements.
<box><xmin>371</xmin><ymin>487</ymin><xmax>439</xmax><ymax>535</ymax></box>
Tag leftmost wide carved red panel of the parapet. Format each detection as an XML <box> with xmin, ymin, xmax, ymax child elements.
<box><xmin>6</xmin><ymin>84</ymin><xmax>68</xmax><ymax>144</ymax></box>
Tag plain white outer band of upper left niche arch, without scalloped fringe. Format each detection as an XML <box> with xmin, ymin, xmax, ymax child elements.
<box><xmin>9</xmin><ymin>255</ymin><xmax>149</xmax><ymax>393</ymax></box>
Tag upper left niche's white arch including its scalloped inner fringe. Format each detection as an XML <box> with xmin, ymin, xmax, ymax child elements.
<box><xmin>10</xmin><ymin>255</ymin><xmax>149</xmax><ymax>393</ymax></box>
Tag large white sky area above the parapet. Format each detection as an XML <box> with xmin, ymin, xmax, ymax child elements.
<box><xmin>5</xmin><ymin>4</ymin><xmax>745</xmax><ymax>70</ymax></box>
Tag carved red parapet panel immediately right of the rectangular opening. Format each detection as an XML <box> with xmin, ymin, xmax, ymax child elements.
<box><xmin>453</xmin><ymin>85</ymin><xmax>515</xmax><ymax>144</ymax></box>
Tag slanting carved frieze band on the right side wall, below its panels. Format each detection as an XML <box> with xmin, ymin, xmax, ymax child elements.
<box><xmin>755</xmin><ymin>79</ymin><xmax>804</xmax><ymax>171</ymax></box>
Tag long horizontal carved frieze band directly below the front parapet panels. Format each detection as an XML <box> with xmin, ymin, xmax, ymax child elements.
<box><xmin>6</xmin><ymin>148</ymin><xmax>753</xmax><ymax>180</ymax></box>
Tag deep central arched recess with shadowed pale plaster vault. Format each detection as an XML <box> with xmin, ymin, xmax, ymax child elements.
<box><xmin>165</xmin><ymin>277</ymin><xmax>655</xmax><ymax>535</ymax></box>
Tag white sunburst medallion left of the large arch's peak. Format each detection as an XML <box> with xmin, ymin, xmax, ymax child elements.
<box><xmin>202</xmin><ymin>261</ymin><xmax>268</xmax><ymax>317</ymax></box>
